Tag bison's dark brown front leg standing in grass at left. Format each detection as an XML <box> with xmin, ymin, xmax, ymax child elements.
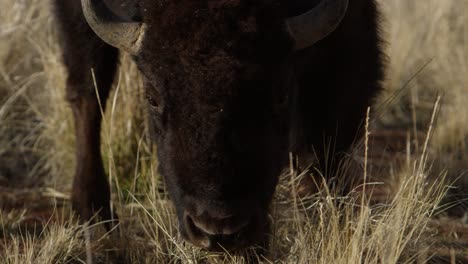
<box><xmin>55</xmin><ymin>0</ymin><xmax>118</xmax><ymax>228</ymax></box>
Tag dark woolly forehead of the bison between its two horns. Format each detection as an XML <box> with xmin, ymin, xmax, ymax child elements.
<box><xmin>138</xmin><ymin>1</ymin><xmax>292</xmax><ymax>88</ymax></box>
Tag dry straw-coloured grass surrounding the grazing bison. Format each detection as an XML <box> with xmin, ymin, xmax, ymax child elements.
<box><xmin>0</xmin><ymin>0</ymin><xmax>468</xmax><ymax>264</ymax></box>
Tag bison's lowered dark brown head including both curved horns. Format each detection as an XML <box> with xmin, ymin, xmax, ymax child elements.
<box><xmin>82</xmin><ymin>0</ymin><xmax>348</xmax><ymax>248</ymax></box>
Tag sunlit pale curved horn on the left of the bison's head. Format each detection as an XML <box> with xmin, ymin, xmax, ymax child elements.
<box><xmin>81</xmin><ymin>0</ymin><xmax>145</xmax><ymax>54</ymax></box>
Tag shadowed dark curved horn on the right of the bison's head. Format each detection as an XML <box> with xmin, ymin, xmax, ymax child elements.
<box><xmin>286</xmin><ymin>0</ymin><xmax>349</xmax><ymax>50</ymax></box>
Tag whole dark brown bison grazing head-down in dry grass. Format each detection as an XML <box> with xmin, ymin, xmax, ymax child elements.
<box><xmin>54</xmin><ymin>0</ymin><xmax>383</xmax><ymax>249</ymax></box>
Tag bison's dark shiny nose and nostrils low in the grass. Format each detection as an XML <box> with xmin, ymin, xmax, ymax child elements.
<box><xmin>184</xmin><ymin>210</ymin><xmax>250</xmax><ymax>249</ymax></box>
